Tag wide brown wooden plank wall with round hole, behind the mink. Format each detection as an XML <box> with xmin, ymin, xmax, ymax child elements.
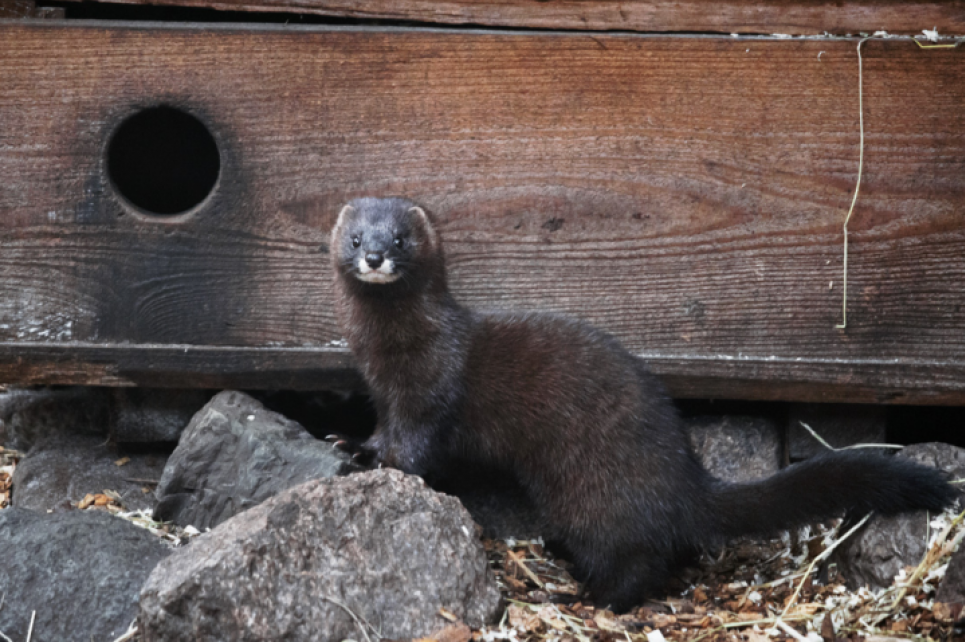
<box><xmin>0</xmin><ymin>21</ymin><xmax>965</xmax><ymax>403</ymax></box>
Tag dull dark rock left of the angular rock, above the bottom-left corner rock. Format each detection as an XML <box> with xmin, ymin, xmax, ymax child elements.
<box><xmin>12</xmin><ymin>435</ymin><xmax>167</xmax><ymax>511</ymax></box>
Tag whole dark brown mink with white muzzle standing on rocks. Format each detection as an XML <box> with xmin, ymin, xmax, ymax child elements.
<box><xmin>331</xmin><ymin>198</ymin><xmax>956</xmax><ymax>610</ymax></box>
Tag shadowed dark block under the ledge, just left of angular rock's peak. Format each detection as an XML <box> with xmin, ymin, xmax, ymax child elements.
<box><xmin>111</xmin><ymin>388</ymin><xmax>213</xmax><ymax>444</ymax></box>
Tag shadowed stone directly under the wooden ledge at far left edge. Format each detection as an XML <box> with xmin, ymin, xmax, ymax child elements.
<box><xmin>0</xmin><ymin>387</ymin><xmax>111</xmax><ymax>452</ymax></box>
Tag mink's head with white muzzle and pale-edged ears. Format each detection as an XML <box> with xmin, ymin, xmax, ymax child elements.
<box><xmin>331</xmin><ymin>198</ymin><xmax>442</xmax><ymax>290</ymax></box>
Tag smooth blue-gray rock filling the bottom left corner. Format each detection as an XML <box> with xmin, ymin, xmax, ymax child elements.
<box><xmin>0</xmin><ymin>508</ymin><xmax>170</xmax><ymax>642</ymax></box>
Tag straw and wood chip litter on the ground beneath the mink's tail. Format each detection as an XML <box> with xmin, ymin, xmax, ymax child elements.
<box><xmin>466</xmin><ymin>504</ymin><xmax>965</xmax><ymax>642</ymax></box>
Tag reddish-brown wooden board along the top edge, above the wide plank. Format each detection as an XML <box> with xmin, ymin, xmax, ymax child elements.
<box><xmin>49</xmin><ymin>0</ymin><xmax>965</xmax><ymax>35</ymax></box>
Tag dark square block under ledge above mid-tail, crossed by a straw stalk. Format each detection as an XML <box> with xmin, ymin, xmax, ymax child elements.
<box><xmin>787</xmin><ymin>403</ymin><xmax>886</xmax><ymax>461</ymax></box>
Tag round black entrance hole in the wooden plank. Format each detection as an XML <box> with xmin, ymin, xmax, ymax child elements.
<box><xmin>107</xmin><ymin>107</ymin><xmax>221</xmax><ymax>216</ymax></box>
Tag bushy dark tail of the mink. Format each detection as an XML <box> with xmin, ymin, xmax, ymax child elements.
<box><xmin>712</xmin><ymin>450</ymin><xmax>958</xmax><ymax>539</ymax></box>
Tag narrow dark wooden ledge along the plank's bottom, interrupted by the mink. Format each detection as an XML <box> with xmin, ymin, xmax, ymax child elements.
<box><xmin>0</xmin><ymin>342</ymin><xmax>965</xmax><ymax>405</ymax></box>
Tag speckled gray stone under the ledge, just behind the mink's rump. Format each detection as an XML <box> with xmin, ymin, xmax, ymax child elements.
<box><xmin>687</xmin><ymin>415</ymin><xmax>782</xmax><ymax>482</ymax></box>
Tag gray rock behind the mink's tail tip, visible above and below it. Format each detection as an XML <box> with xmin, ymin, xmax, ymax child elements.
<box><xmin>835</xmin><ymin>443</ymin><xmax>965</xmax><ymax>588</ymax></box>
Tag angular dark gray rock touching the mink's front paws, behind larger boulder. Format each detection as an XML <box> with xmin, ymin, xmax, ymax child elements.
<box><xmin>155</xmin><ymin>391</ymin><xmax>358</xmax><ymax>530</ymax></box>
